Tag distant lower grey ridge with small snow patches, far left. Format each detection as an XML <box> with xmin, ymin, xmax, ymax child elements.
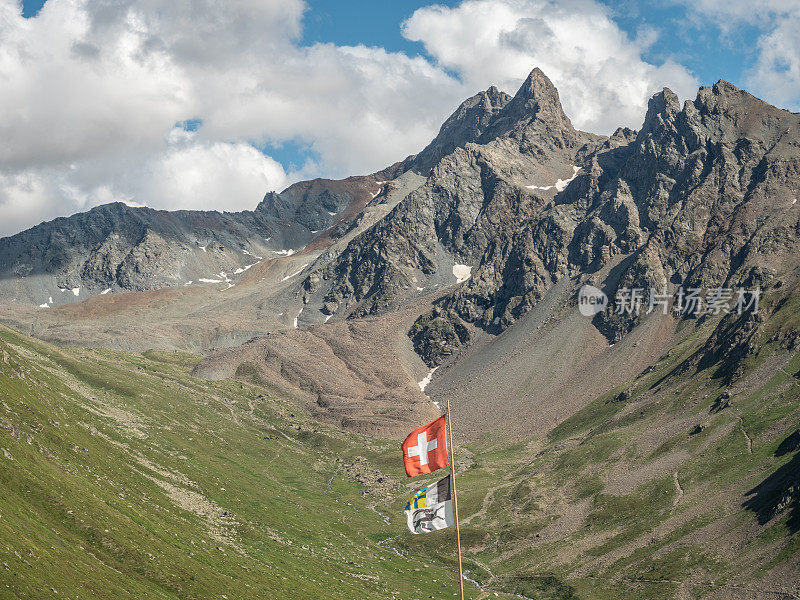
<box><xmin>0</xmin><ymin>176</ymin><xmax>384</xmax><ymax>305</ymax></box>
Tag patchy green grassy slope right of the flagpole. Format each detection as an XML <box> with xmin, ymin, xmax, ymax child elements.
<box><xmin>376</xmin><ymin>296</ymin><xmax>800</xmax><ymax>600</ymax></box>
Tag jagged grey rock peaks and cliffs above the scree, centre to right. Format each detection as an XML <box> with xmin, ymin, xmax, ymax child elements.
<box><xmin>302</xmin><ymin>70</ymin><xmax>800</xmax><ymax>365</ymax></box>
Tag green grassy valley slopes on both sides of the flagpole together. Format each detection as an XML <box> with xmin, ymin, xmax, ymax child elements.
<box><xmin>0</xmin><ymin>288</ymin><xmax>800</xmax><ymax>600</ymax></box>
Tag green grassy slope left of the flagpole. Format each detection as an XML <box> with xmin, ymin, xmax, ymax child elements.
<box><xmin>0</xmin><ymin>328</ymin><xmax>503</xmax><ymax>599</ymax></box>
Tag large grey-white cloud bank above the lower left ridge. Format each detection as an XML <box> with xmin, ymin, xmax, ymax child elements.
<box><xmin>0</xmin><ymin>0</ymin><xmax>463</xmax><ymax>234</ymax></box>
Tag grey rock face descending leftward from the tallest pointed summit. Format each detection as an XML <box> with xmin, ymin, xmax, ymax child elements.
<box><xmin>316</xmin><ymin>72</ymin><xmax>605</xmax><ymax>326</ymax></box>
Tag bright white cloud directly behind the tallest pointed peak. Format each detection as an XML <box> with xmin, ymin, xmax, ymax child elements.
<box><xmin>404</xmin><ymin>0</ymin><xmax>697</xmax><ymax>134</ymax></box>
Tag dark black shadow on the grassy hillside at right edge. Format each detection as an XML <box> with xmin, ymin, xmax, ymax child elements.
<box><xmin>742</xmin><ymin>432</ymin><xmax>800</xmax><ymax>533</ymax></box>
